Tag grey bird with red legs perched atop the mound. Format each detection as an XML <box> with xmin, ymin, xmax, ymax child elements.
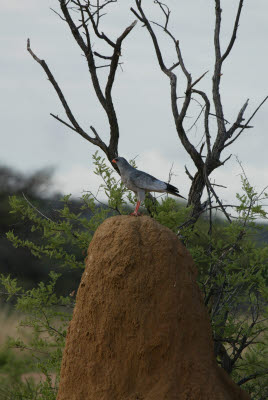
<box><xmin>112</xmin><ymin>157</ymin><xmax>186</xmax><ymax>217</ymax></box>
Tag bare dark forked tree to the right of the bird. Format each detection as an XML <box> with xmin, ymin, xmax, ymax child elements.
<box><xmin>131</xmin><ymin>0</ymin><xmax>268</xmax><ymax>224</ymax></box>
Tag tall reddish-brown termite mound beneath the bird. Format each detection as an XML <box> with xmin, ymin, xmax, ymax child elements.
<box><xmin>57</xmin><ymin>216</ymin><xmax>249</xmax><ymax>400</ymax></box>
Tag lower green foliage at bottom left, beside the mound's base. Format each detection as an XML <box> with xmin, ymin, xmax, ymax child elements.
<box><xmin>0</xmin><ymin>272</ymin><xmax>74</xmax><ymax>400</ymax></box>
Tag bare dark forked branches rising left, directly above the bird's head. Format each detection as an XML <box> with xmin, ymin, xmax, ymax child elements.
<box><xmin>27</xmin><ymin>0</ymin><xmax>137</xmax><ymax>167</ymax></box>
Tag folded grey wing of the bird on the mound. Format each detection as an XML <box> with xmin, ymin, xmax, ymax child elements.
<box><xmin>128</xmin><ymin>169</ymin><xmax>167</xmax><ymax>192</ymax></box>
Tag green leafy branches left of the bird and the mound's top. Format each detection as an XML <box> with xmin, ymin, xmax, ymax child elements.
<box><xmin>6</xmin><ymin>152</ymin><xmax>137</xmax><ymax>269</ymax></box>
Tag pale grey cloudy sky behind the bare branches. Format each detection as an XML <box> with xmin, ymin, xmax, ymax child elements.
<box><xmin>0</xmin><ymin>0</ymin><xmax>268</xmax><ymax>203</ymax></box>
